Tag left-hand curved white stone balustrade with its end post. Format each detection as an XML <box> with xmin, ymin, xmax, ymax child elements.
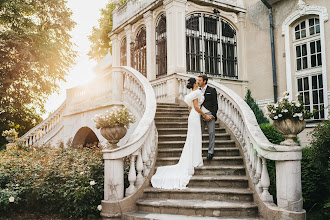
<box><xmin>101</xmin><ymin>67</ymin><xmax>158</xmax><ymax>217</ymax></box>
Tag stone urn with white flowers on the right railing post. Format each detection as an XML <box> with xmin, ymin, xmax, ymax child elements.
<box><xmin>266</xmin><ymin>92</ymin><xmax>313</xmax><ymax>146</ymax></box>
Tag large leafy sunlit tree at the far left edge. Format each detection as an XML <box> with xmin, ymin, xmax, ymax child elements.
<box><xmin>0</xmin><ymin>0</ymin><xmax>76</xmax><ymax>148</ymax></box>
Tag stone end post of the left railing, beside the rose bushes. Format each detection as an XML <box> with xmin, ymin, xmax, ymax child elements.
<box><xmin>101</xmin><ymin>150</ymin><xmax>124</xmax><ymax>219</ymax></box>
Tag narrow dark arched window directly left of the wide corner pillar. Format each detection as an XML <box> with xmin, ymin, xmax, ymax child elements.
<box><xmin>156</xmin><ymin>14</ymin><xmax>167</xmax><ymax>77</ymax></box>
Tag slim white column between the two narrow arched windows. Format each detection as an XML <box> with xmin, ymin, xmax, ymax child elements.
<box><xmin>143</xmin><ymin>11</ymin><xmax>156</xmax><ymax>81</ymax></box>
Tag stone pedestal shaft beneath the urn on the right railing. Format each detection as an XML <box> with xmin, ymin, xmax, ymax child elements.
<box><xmin>276</xmin><ymin>160</ymin><xmax>303</xmax><ymax>212</ymax></box>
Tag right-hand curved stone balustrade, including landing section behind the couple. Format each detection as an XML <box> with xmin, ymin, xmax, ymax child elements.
<box><xmin>153</xmin><ymin>73</ymin><xmax>305</xmax><ymax>218</ymax></box>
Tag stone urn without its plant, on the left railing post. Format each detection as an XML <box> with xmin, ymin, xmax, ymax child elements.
<box><xmin>100</xmin><ymin>124</ymin><xmax>127</xmax><ymax>148</ymax></box>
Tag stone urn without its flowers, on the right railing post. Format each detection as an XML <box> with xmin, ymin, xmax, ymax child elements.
<box><xmin>273</xmin><ymin>119</ymin><xmax>306</xmax><ymax>146</ymax></box>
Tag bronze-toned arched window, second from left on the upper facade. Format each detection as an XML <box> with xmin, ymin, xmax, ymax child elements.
<box><xmin>131</xmin><ymin>27</ymin><xmax>147</xmax><ymax>77</ymax></box>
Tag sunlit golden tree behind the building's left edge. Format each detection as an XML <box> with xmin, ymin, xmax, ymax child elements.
<box><xmin>88</xmin><ymin>1</ymin><xmax>116</xmax><ymax>61</ymax></box>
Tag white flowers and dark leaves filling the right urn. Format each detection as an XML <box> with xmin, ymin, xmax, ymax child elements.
<box><xmin>266</xmin><ymin>92</ymin><xmax>315</xmax><ymax>120</ymax></box>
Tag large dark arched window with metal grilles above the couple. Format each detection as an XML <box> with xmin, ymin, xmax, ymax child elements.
<box><xmin>186</xmin><ymin>13</ymin><xmax>238</xmax><ymax>78</ymax></box>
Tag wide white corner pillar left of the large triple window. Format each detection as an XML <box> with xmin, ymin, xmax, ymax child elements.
<box><xmin>163</xmin><ymin>0</ymin><xmax>187</xmax><ymax>75</ymax></box>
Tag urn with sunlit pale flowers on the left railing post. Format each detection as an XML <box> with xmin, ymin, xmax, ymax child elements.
<box><xmin>93</xmin><ymin>107</ymin><xmax>136</xmax><ymax>147</ymax></box>
